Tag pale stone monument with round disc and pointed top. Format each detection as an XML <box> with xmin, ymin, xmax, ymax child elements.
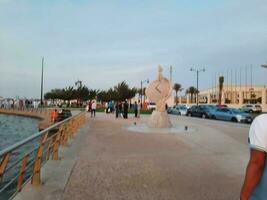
<box><xmin>146</xmin><ymin>65</ymin><xmax>172</xmax><ymax>128</ymax></box>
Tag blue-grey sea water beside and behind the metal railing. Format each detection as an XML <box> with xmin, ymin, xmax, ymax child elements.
<box><xmin>0</xmin><ymin>114</ymin><xmax>39</xmax><ymax>200</ymax></box>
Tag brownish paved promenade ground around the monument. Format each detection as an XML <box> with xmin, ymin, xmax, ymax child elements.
<box><xmin>62</xmin><ymin>113</ymin><xmax>249</xmax><ymax>200</ymax></box>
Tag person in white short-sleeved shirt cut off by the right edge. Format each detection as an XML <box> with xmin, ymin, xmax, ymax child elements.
<box><xmin>240</xmin><ymin>114</ymin><xmax>267</xmax><ymax>200</ymax></box>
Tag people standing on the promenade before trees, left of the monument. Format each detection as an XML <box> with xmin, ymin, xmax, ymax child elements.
<box><xmin>86</xmin><ymin>100</ymin><xmax>141</xmax><ymax>119</ymax></box>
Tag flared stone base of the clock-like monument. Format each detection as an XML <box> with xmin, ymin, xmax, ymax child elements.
<box><xmin>148</xmin><ymin>111</ymin><xmax>172</xmax><ymax>128</ymax></box>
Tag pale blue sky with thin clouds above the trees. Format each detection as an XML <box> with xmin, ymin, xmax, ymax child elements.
<box><xmin>0</xmin><ymin>0</ymin><xmax>267</xmax><ymax>98</ymax></box>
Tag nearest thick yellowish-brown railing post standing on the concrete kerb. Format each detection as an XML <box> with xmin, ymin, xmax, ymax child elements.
<box><xmin>31</xmin><ymin>133</ymin><xmax>48</xmax><ymax>185</ymax></box>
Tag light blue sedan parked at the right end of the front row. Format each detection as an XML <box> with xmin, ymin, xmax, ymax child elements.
<box><xmin>211</xmin><ymin>108</ymin><xmax>253</xmax><ymax>123</ymax></box>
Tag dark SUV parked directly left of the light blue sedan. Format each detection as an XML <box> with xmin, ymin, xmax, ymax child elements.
<box><xmin>186</xmin><ymin>105</ymin><xmax>215</xmax><ymax>118</ymax></box>
